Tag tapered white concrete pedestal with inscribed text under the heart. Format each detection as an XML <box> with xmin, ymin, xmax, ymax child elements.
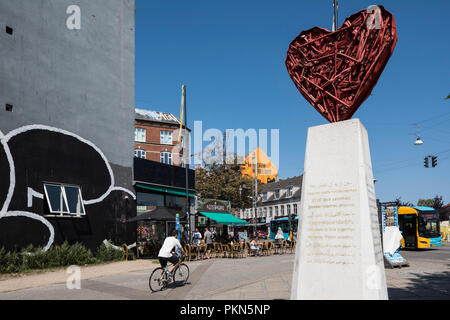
<box><xmin>291</xmin><ymin>119</ymin><xmax>388</xmax><ymax>300</ymax></box>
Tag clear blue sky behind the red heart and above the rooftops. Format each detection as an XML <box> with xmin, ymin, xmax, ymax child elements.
<box><xmin>136</xmin><ymin>0</ymin><xmax>450</xmax><ymax>203</ymax></box>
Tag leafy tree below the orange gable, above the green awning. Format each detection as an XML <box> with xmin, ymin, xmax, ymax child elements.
<box><xmin>195</xmin><ymin>158</ymin><xmax>259</xmax><ymax>209</ymax></box>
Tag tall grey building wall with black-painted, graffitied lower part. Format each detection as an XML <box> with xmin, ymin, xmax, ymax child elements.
<box><xmin>0</xmin><ymin>0</ymin><xmax>136</xmax><ymax>250</ymax></box>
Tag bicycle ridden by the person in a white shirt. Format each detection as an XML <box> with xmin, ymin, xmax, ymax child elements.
<box><xmin>148</xmin><ymin>257</ymin><xmax>189</xmax><ymax>292</ymax></box>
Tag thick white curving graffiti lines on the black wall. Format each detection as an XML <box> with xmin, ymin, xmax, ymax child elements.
<box><xmin>0</xmin><ymin>125</ymin><xmax>136</xmax><ymax>250</ymax></box>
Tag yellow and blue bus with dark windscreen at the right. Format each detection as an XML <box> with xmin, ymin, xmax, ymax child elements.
<box><xmin>398</xmin><ymin>207</ymin><xmax>442</xmax><ymax>249</ymax></box>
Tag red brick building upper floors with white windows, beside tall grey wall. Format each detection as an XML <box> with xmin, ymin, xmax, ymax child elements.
<box><xmin>134</xmin><ymin>109</ymin><xmax>190</xmax><ymax>167</ymax></box>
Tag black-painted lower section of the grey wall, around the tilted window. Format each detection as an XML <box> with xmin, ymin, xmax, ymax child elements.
<box><xmin>0</xmin><ymin>130</ymin><xmax>136</xmax><ymax>250</ymax></box>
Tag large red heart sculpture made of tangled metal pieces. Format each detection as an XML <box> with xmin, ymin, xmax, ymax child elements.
<box><xmin>286</xmin><ymin>6</ymin><xmax>397</xmax><ymax>122</ymax></box>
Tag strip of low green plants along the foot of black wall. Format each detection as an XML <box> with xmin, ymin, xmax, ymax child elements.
<box><xmin>0</xmin><ymin>242</ymin><xmax>123</xmax><ymax>273</ymax></box>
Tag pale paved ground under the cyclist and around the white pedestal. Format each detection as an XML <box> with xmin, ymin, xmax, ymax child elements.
<box><xmin>0</xmin><ymin>244</ymin><xmax>450</xmax><ymax>300</ymax></box>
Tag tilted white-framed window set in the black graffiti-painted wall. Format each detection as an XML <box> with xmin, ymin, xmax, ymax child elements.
<box><xmin>44</xmin><ymin>184</ymin><xmax>85</xmax><ymax>216</ymax></box>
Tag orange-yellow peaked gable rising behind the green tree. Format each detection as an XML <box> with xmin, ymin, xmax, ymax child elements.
<box><xmin>241</xmin><ymin>148</ymin><xmax>278</xmax><ymax>183</ymax></box>
